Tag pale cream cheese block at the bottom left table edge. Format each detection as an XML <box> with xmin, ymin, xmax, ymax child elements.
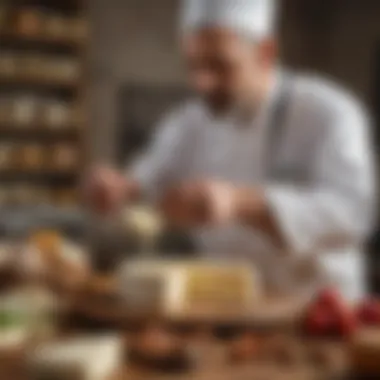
<box><xmin>28</xmin><ymin>336</ymin><xmax>123</xmax><ymax>380</ymax></box>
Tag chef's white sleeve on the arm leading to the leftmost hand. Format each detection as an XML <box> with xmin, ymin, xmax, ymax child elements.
<box><xmin>129</xmin><ymin>107</ymin><xmax>188</xmax><ymax>200</ymax></box>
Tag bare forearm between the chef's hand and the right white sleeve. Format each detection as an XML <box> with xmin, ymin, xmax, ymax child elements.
<box><xmin>236</xmin><ymin>188</ymin><xmax>285</xmax><ymax>248</ymax></box>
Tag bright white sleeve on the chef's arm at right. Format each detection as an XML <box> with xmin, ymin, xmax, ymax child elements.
<box><xmin>267</xmin><ymin>99</ymin><xmax>375</xmax><ymax>254</ymax></box>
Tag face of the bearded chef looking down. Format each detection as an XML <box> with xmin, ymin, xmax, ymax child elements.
<box><xmin>183</xmin><ymin>28</ymin><xmax>272</xmax><ymax>112</ymax></box>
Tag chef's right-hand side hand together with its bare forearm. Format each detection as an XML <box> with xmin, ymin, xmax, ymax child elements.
<box><xmin>160</xmin><ymin>181</ymin><xmax>284</xmax><ymax>247</ymax></box>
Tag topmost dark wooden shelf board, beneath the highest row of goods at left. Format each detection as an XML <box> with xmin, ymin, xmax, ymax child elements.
<box><xmin>0</xmin><ymin>31</ymin><xmax>86</xmax><ymax>49</ymax></box>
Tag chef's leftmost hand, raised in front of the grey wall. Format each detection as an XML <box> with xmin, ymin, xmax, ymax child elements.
<box><xmin>83</xmin><ymin>166</ymin><xmax>138</xmax><ymax>215</ymax></box>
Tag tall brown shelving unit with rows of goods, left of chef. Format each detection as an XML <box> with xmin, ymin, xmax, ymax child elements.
<box><xmin>0</xmin><ymin>0</ymin><xmax>88</xmax><ymax>233</ymax></box>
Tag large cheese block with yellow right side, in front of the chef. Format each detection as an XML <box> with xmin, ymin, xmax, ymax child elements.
<box><xmin>118</xmin><ymin>260</ymin><xmax>261</xmax><ymax>313</ymax></box>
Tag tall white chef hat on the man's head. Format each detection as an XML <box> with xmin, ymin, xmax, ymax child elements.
<box><xmin>181</xmin><ymin>0</ymin><xmax>277</xmax><ymax>38</ymax></box>
